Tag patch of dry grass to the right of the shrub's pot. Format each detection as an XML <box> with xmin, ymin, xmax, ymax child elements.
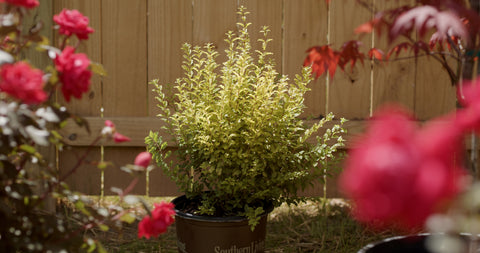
<box><xmin>266</xmin><ymin>199</ymin><xmax>394</xmax><ymax>253</ymax></box>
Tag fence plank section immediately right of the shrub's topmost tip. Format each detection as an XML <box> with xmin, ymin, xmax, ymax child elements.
<box><xmin>239</xmin><ymin>0</ymin><xmax>283</xmax><ymax>70</ymax></box>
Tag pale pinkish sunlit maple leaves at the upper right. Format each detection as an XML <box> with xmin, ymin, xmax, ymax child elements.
<box><xmin>389</xmin><ymin>5</ymin><xmax>468</xmax><ymax>41</ymax></box>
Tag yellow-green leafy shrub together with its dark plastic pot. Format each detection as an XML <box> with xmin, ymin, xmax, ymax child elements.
<box><xmin>146</xmin><ymin>8</ymin><xmax>344</xmax><ymax>252</ymax></box>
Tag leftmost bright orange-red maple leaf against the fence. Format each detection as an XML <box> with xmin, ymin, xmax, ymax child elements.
<box><xmin>303</xmin><ymin>45</ymin><xmax>339</xmax><ymax>78</ymax></box>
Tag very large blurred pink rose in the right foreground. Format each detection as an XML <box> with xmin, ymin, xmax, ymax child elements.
<box><xmin>340</xmin><ymin>108</ymin><xmax>463</xmax><ymax>230</ymax></box>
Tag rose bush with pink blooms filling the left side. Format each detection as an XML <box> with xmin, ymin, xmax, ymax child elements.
<box><xmin>0</xmin><ymin>0</ymin><xmax>173</xmax><ymax>252</ymax></box>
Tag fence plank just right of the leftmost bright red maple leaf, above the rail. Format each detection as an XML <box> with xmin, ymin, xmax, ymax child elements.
<box><xmin>328</xmin><ymin>0</ymin><xmax>372</xmax><ymax>119</ymax></box>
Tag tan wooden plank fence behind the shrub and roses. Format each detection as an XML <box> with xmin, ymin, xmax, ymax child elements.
<box><xmin>35</xmin><ymin>0</ymin><xmax>455</xmax><ymax>196</ymax></box>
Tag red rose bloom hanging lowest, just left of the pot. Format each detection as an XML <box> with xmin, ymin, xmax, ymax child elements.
<box><xmin>138</xmin><ymin>202</ymin><xmax>175</xmax><ymax>239</ymax></box>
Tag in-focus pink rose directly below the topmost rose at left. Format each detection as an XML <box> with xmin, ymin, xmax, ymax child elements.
<box><xmin>55</xmin><ymin>46</ymin><xmax>92</xmax><ymax>102</ymax></box>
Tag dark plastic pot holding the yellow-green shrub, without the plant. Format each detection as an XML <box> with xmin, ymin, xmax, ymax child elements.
<box><xmin>172</xmin><ymin>195</ymin><xmax>273</xmax><ymax>253</ymax></box>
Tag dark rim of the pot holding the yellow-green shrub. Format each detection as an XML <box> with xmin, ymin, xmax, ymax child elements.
<box><xmin>172</xmin><ymin>195</ymin><xmax>274</xmax><ymax>222</ymax></box>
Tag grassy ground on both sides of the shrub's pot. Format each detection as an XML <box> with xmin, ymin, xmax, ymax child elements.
<box><xmin>84</xmin><ymin>198</ymin><xmax>395</xmax><ymax>253</ymax></box>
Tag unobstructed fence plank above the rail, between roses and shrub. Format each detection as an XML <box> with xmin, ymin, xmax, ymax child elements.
<box><xmin>101</xmin><ymin>0</ymin><xmax>148</xmax><ymax>117</ymax></box>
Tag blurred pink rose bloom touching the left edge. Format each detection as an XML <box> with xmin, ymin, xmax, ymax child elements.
<box><xmin>0</xmin><ymin>62</ymin><xmax>47</xmax><ymax>104</ymax></box>
